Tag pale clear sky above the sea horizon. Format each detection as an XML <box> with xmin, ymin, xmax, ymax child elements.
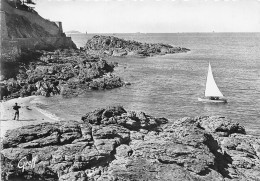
<box><xmin>35</xmin><ymin>0</ymin><xmax>260</xmax><ymax>33</ymax></box>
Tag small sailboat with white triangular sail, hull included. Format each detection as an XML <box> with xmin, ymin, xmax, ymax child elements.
<box><xmin>198</xmin><ymin>63</ymin><xmax>227</xmax><ymax>103</ymax></box>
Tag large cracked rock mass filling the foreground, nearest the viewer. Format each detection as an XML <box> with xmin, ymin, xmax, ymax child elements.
<box><xmin>1</xmin><ymin>106</ymin><xmax>260</xmax><ymax>181</ymax></box>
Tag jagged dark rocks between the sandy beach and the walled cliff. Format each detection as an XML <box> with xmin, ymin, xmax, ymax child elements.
<box><xmin>0</xmin><ymin>49</ymin><xmax>124</xmax><ymax>98</ymax></box>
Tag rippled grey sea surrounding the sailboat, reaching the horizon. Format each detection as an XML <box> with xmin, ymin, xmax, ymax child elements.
<box><xmin>38</xmin><ymin>33</ymin><xmax>260</xmax><ymax>135</ymax></box>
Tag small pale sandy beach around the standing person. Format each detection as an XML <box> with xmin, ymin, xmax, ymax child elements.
<box><xmin>0</xmin><ymin>96</ymin><xmax>59</xmax><ymax>138</ymax></box>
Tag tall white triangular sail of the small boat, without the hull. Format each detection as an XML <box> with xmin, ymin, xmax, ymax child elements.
<box><xmin>205</xmin><ymin>63</ymin><xmax>223</xmax><ymax>97</ymax></box>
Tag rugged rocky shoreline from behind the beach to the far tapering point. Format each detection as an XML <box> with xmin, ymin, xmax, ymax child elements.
<box><xmin>0</xmin><ymin>35</ymin><xmax>189</xmax><ymax>99</ymax></box>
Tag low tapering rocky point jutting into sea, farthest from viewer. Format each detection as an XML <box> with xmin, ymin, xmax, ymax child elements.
<box><xmin>84</xmin><ymin>35</ymin><xmax>189</xmax><ymax>57</ymax></box>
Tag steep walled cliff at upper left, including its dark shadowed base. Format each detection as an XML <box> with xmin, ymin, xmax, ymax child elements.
<box><xmin>0</xmin><ymin>0</ymin><xmax>80</xmax><ymax>90</ymax></box>
